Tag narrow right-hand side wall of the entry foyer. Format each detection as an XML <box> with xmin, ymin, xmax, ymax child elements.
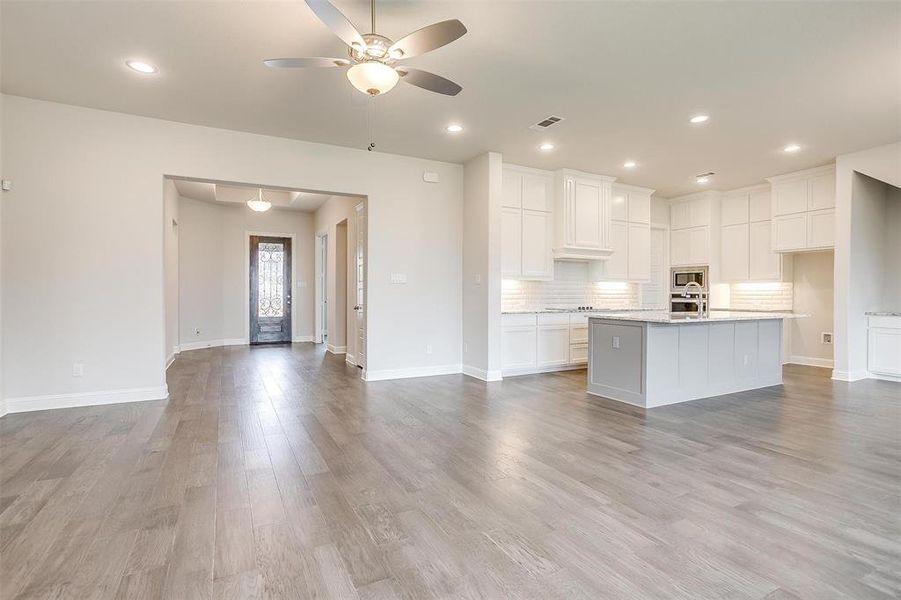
<box><xmin>314</xmin><ymin>196</ymin><xmax>365</xmax><ymax>360</ymax></box>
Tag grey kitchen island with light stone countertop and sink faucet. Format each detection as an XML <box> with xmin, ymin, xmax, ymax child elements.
<box><xmin>588</xmin><ymin>310</ymin><xmax>798</xmax><ymax>408</ymax></box>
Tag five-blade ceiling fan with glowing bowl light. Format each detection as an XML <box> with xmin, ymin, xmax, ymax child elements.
<box><xmin>263</xmin><ymin>0</ymin><xmax>466</xmax><ymax>96</ymax></box>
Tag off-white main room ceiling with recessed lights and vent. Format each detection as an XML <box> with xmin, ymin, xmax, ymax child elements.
<box><xmin>0</xmin><ymin>0</ymin><xmax>901</xmax><ymax>196</ymax></box>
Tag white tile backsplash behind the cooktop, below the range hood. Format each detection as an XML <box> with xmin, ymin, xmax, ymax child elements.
<box><xmin>501</xmin><ymin>261</ymin><xmax>640</xmax><ymax>311</ymax></box>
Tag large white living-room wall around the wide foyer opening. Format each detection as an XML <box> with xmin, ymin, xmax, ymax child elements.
<box><xmin>0</xmin><ymin>96</ymin><xmax>464</xmax><ymax>404</ymax></box>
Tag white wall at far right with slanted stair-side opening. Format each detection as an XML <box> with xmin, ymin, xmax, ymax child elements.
<box><xmin>832</xmin><ymin>142</ymin><xmax>901</xmax><ymax>381</ymax></box>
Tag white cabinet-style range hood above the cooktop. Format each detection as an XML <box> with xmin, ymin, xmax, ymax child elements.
<box><xmin>554</xmin><ymin>169</ymin><xmax>613</xmax><ymax>260</ymax></box>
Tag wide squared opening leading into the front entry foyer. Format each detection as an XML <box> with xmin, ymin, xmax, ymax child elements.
<box><xmin>162</xmin><ymin>176</ymin><xmax>368</xmax><ymax>375</ymax></box>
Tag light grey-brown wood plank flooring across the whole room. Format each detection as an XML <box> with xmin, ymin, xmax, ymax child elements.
<box><xmin>0</xmin><ymin>344</ymin><xmax>901</xmax><ymax>600</ymax></box>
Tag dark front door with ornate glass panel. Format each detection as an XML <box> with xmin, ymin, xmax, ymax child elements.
<box><xmin>250</xmin><ymin>235</ymin><xmax>291</xmax><ymax>344</ymax></box>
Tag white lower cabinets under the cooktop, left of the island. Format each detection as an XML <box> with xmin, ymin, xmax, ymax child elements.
<box><xmin>501</xmin><ymin>313</ymin><xmax>588</xmax><ymax>376</ymax></box>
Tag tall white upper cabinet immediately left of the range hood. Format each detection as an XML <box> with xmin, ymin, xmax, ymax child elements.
<box><xmin>501</xmin><ymin>165</ymin><xmax>554</xmax><ymax>280</ymax></box>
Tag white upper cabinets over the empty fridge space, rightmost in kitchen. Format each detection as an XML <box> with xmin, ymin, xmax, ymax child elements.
<box><xmin>767</xmin><ymin>165</ymin><xmax>835</xmax><ymax>252</ymax></box>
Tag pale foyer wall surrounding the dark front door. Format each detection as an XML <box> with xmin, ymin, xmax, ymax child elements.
<box><xmin>178</xmin><ymin>198</ymin><xmax>314</xmax><ymax>350</ymax></box>
